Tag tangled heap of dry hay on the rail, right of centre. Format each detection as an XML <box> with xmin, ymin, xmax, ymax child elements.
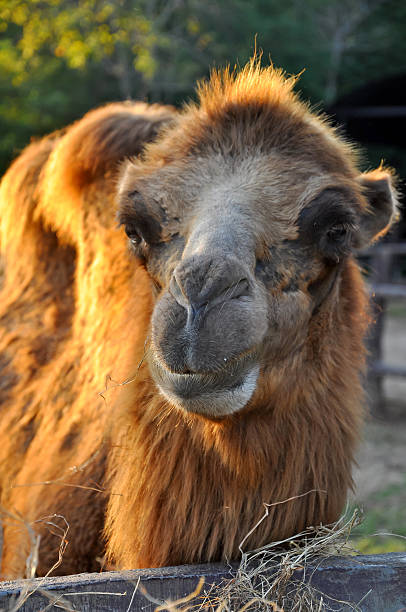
<box><xmin>198</xmin><ymin>510</ymin><xmax>361</xmax><ymax>612</ymax></box>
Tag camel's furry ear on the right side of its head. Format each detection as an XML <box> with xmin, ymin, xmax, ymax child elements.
<box><xmin>357</xmin><ymin>169</ymin><xmax>398</xmax><ymax>248</ymax></box>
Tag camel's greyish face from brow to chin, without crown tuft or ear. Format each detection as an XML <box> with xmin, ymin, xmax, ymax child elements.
<box><xmin>119</xmin><ymin>139</ymin><xmax>390</xmax><ymax>417</ymax></box>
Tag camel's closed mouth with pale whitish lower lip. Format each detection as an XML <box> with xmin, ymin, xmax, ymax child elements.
<box><xmin>150</xmin><ymin>356</ymin><xmax>259</xmax><ymax>417</ymax></box>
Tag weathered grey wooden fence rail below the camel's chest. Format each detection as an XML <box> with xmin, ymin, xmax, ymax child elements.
<box><xmin>0</xmin><ymin>553</ymin><xmax>406</xmax><ymax>612</ymax></box>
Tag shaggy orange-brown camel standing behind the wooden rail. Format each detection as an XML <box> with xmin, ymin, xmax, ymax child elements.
<box><xmin>0</xmin><ymin>60</ymin><xmax>396</xmax><ymax>578</ymax></box>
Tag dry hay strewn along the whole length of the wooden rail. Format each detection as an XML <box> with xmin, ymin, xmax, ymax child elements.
<box><xmin>3</xmin><ymin>502</ymin><xmax>400</xmax><ymax>612</ymax></box>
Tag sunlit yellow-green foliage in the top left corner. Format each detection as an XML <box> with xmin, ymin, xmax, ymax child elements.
<box><xmin>0</xmin><ymin>0</ymin><xmax>155</xmax><ymax>80</ymax></box>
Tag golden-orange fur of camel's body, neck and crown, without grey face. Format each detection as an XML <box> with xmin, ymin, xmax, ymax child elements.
<box><xmin>0</xmin><ymin>63</ymin><xmax>394</xmax><ymax>577</ymax></box>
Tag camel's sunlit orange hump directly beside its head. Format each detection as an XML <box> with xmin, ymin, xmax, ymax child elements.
<box><xmin>39</xmin><ymin>102</ymin><xmax>175</xmax><ymax>242</ymax></box>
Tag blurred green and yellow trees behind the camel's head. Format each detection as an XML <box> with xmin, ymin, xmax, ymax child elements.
<box><xmin>0</xmin><ymin>0</ymin><xmax>406</xmax><ymax>180</ymax></box>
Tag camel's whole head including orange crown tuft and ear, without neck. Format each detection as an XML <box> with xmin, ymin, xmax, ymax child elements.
<box><xmin>119</xmin><ymin>62</ymin><xmax>394</xmax><ymax>417</ymax></box>
